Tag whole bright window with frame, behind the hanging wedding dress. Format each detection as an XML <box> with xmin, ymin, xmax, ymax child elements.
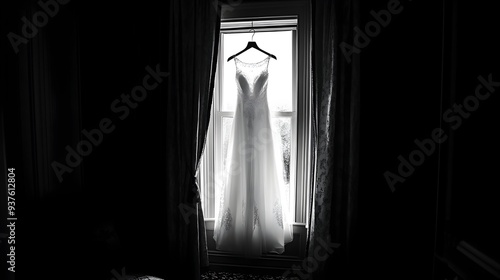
<box><xmin>198</xmin><ymin>7</ymin><xmax>310</xmax><ymax>234</ymax></box>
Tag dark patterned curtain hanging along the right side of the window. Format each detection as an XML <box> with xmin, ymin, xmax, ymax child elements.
<box><xmin>308</xmin><ymin>0</ymin><xmax>359</xmax><ymax>279</ymax></box>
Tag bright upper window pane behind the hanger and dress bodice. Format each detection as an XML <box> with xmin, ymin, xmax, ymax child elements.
<box><xmin>221</xmin><ymin>31</ymin><xmax>293</xmax><ymax>112</ymax></box>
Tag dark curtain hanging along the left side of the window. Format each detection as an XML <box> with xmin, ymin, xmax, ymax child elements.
<box><xmin>165</xmin><ymin>0</ymin><xmax>220</xmax><ymax>279</ymax></box>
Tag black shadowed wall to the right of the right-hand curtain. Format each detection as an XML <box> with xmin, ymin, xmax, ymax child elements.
<box><xmin>357</xmin><ymin>1</ymin><xmax>500</xmax><ymax>279</ymax></box>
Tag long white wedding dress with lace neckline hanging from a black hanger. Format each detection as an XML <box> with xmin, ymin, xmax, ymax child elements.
<box><xmin>214</xmin><ymin>57</ymin><xmax>292</xmax><ymax>256</ymax></box>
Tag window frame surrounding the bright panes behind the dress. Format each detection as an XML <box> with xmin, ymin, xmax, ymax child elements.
<box><xmin>199</xmin><ymin>1</ymin><xmax>312</xmax><ymax>234</ymax></box>
